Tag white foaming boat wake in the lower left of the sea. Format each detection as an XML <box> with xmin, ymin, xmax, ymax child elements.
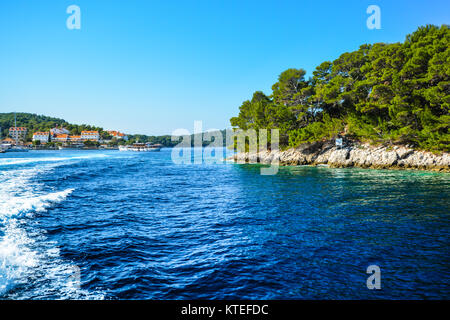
<box><xmin>0</xmin><ymin>164</ymin><xmax>103</xmax><ymax>299</ymax></box>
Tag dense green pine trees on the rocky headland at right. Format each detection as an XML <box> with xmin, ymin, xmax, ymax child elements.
<box><xmin>230</xmin><ymin>25</ymin><xmax>450</xmax><ymax>152</ymax></box>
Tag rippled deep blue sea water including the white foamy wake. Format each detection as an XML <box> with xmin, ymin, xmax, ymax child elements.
<box><xmin>0</xmin><ymin>149</ymin><xmax>450</xmax><ymax>299</ymax></box>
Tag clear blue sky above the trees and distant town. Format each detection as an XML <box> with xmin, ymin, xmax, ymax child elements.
<box><xmin>0</xmin><ymin>0</ymin><xmax>450</xmax><ymax>134</ymax></box>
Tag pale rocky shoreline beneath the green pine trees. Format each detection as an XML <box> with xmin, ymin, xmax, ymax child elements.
<box><xmin>228</xmin><ymin>140</ymin><xmax>450</xmax><ymax>172</ymax></box>
